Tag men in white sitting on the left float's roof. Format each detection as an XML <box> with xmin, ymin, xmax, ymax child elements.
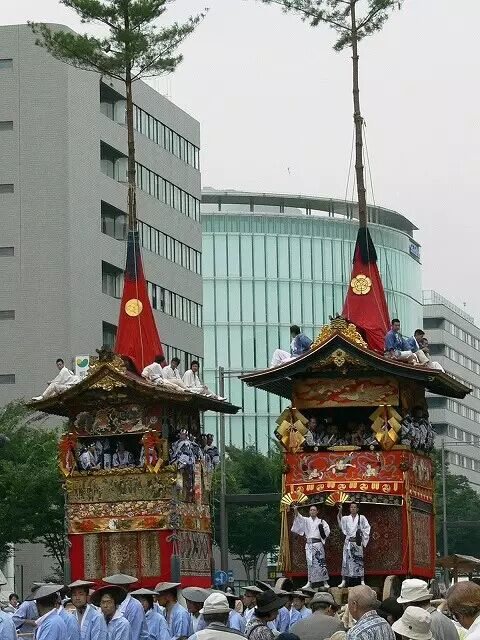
<box><xmin>32</xmin><ymin>355</ymin><xmax>226</xmax><ymax>402</ymax></box>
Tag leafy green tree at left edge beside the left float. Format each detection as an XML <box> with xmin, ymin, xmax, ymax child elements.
<box><xmin>0</xmin><ymin>402</ymin><xmax>65</xmax><ymax>575</ymax></box>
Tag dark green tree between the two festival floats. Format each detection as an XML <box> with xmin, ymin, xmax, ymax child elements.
<box><xmin>214</xmin><ymin>446</ymin><xmax>283</xmax><ymax>580</ymax></box>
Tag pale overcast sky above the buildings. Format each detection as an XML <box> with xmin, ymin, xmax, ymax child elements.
<box><xmin>4</xmin><ymin>0</ymin><xmax>480</xmax><ymax>318</ymax></box>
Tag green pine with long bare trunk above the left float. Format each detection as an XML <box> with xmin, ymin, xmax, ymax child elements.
<box><xmin>30</xmin><ymin>0</ymin><xmax>204</xmax><ymax>230</ymax></box>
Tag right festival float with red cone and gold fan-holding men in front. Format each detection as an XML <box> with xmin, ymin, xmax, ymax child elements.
<box><xmin>242</xmin><ymin>228</ymin><xmax>470</xmax><ymax>588</ymax></box>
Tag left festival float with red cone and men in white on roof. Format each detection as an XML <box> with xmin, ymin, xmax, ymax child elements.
<box><xmin>29</xmin><ymin>231</ymin><xmax>238</xmax><ymax>588</ymax></box>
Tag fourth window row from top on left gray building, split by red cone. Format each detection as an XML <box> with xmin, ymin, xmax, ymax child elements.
<box><xmin>102</xmin><ymin>261</ymin><xmax>202</xmax><ymax>327</ymax></box>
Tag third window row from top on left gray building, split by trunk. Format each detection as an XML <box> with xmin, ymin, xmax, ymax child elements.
<box><xmin>102</xmin><ymin>202</ymin><xmax>202</xmax><ymax>274</ymax></box>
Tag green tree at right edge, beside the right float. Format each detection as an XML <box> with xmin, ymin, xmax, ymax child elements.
<box><xmin>434</xmin><ymin>451</ymin><xmax>480</xmax><ymax>557</ymax></box>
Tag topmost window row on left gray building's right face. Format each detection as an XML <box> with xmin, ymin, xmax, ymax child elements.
<box><xmin>133</xmin><ymin>105</ymin><xmax>200</xmax><ymax>169</ymax></box>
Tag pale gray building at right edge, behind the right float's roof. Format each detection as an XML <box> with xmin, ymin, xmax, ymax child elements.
<box><xmin>423</xmin><ymin>291</ymin><xmax>480</xmax><ymax>491</ymax></box>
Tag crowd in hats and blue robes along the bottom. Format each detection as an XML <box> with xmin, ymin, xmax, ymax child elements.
<box><xmin>0</xmin><ymin>574</ymin><xmax>480</xmax><ymax>640</ymax></box>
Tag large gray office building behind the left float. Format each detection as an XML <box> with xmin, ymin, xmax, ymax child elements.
<box><xmin>0</xmin><ymin>25</ymin><xmax>203</xmax><ymax>595</ymax></box>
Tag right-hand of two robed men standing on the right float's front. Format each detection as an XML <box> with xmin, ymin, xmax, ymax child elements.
<box><xmin>337</xmin><ymin>502</ymin><xmax>370</xmax><ymax>587</ymax></box>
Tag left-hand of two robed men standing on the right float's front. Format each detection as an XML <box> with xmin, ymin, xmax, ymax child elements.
<box><xmin>292</xmin><ymin>505</ymin><xmax>330</xmax><ymax>587</ymax></box>
